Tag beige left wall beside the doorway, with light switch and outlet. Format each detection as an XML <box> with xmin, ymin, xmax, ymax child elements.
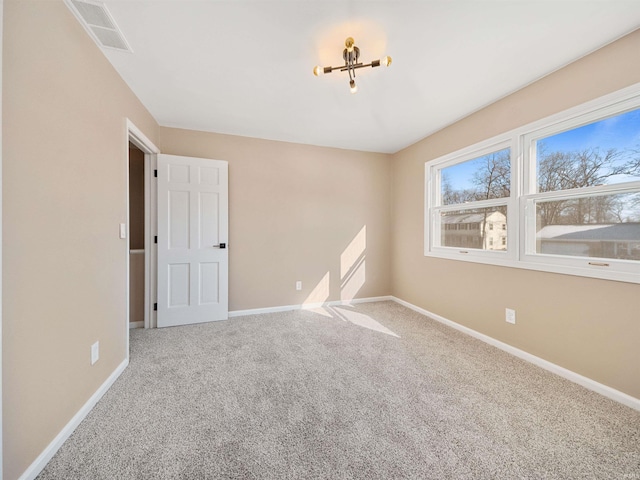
<box><xmin>2</xmin><ymin>0</ymin><xmax>157</xmax><ymax>480</ymax></box>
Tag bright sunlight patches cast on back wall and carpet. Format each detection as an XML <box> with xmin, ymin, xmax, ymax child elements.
<box><xmin>302</xmin><ymin>225</ymin><xmax>400</xmax><ymax>338</ymax></box>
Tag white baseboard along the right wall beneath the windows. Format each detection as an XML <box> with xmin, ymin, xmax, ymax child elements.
<box><xmin>391</xmin><ymin>297</ymin><xmax>640</xmax><ymax>411</ymax></box>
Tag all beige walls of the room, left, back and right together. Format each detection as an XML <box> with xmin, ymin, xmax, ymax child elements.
<box><xmin>2</xmin><ymin>0</ymin><xmax>640</xmax><ymax>480</ymax></box>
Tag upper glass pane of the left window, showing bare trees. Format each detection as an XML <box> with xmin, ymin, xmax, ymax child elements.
<box><xmin>440</xmin><ymin>148</ymin><xmax>511</xmax><ymax>205</ymax></box>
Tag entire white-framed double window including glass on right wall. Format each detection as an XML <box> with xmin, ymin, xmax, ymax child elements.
<box><xmin>425</xmin><ymin>86</ymin><xmax>640</xmax><ymax>283</ymax></box>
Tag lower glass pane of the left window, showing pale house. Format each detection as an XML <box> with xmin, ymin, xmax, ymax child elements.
<box><xmin>440</xmin><ymin>206</ymin><xmax>507</xmax><ymax>251</ymax></box>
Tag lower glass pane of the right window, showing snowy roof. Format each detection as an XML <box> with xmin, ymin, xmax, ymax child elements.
<box><xmin>536</xmin><ymin>192</ymin><xmax>640</xmax><ymax>260</ymax></box>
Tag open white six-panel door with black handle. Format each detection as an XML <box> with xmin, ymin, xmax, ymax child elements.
<box><xmin>158</xmin><ymin>155</ymin><xmax>229</xmax><ymax>327</ymax></box>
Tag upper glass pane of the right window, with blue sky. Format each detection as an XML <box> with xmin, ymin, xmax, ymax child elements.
<box><xmin>536</xmin><ymin>109</ymin><xmax>640</xmax><ymax>192</ymax></box>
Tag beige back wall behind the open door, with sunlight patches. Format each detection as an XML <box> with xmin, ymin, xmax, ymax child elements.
<box><xmin>160</xmin><ymin>127</ymin><xmax>391</xmax><ymax>310</ymax></box>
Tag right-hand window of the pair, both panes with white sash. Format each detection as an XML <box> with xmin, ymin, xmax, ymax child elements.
<box><xmin>524</xmin><ymin>105</ymin><xmax>640</xmax><ymax>278</ymax></box>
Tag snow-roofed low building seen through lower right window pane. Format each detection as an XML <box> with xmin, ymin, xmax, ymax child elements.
<box><xmin>536</xmin><ymin>223</ymin><xmax>640</xmax><ymax>260</ymax></box>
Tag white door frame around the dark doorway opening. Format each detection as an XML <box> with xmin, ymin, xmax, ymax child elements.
<box><xmin>125</xmin><ymin>118</ymin><xmax>160</xmax><ymax>342</ymax></box>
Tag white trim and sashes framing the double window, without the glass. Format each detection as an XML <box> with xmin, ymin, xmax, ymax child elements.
<box><xmin>424</xmin><ymin>83</ymin><xmax>640</xmax><ymax>283</ymax></box>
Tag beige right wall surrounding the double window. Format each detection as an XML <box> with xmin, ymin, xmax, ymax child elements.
<box><xmin>392</xmin><ymin>31</ymin><xmax>640</xmax><ymax>398</ymax></box>
